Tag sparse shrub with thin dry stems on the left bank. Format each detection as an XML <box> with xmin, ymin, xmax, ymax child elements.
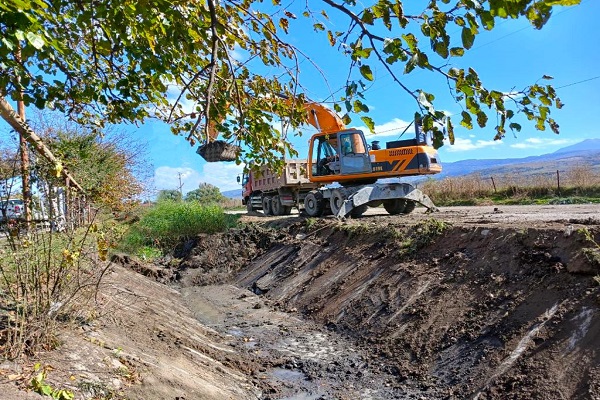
<box><xmin>0</xmin><ymin>212</ymin><xmax>119</xmax><ymax>358</ymax></box>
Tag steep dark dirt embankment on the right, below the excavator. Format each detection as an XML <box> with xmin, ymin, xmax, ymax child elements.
<box><xmin>176</xmin><ymin>217</ymin><xmax>600</xmax><ymax>399</ymax></box>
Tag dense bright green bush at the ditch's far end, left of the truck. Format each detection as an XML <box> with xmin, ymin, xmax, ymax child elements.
<box><xmin>122</xmin><ymin>200</ymin><xmax>238</xmax><ymax>255</ymax></box>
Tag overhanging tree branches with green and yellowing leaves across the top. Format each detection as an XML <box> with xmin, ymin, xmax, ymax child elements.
<box><xmin>0</xmin><ymin>0</ymin><xmax>580</xmax><ymax>170</ymax></box>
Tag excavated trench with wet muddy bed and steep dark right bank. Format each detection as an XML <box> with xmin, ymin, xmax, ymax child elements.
<box><xmin>156</xmin><ymin>218</ymin><xmax>600</xmax><ymax>399</ymax></box>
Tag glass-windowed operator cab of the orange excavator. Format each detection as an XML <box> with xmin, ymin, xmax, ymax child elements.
<box><xmin>309</xmin><ymin>129</ymin><xmax>372</xmax><ymax>183</ymax></box>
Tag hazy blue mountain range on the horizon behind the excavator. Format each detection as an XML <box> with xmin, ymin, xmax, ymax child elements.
<box><xmin>222</xmin><ymin>139</ymin><xmax>600</xmax><ymax>199</ymax></box>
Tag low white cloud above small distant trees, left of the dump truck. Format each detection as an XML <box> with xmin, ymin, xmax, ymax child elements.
<box><xmin>154</xmin><ymin>162</ymin><xmax>244</xmax><ymax>194</ymax></box>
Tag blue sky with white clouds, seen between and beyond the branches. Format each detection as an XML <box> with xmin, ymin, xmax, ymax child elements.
<box><xmin>3</xmin><ymin>0</ymin><xmax>600</xmax><ymax>197</ymax></box>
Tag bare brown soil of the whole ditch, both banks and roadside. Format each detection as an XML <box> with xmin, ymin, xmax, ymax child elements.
<box><xmin>0</xmin><ymin>205</ymin><xmax>600</xmax><ymax>400</ymax></box>
